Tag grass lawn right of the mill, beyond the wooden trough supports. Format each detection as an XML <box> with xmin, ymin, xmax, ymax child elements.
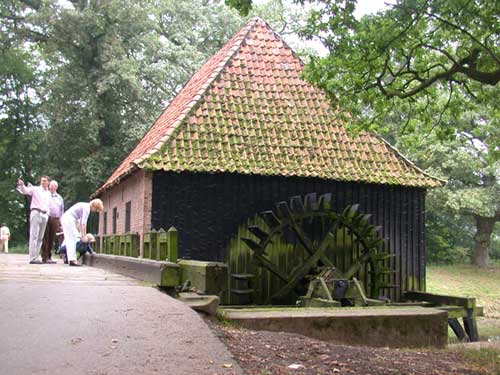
<box><xmin>427</xmin><ymin>263</ymin><xmax>500</xmax><ymax>341</ymax></box>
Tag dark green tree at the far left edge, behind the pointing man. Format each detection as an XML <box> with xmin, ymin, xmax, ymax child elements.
<box><xmin>0</xmin><ymin>1</ymin><xmax>44</xmax><ymax>242</ymax></box>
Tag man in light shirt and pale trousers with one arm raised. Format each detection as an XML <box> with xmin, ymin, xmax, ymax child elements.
<box><xmin>17</xmin><ymin>176</ymin><xmax>50</xmax><ymax>264</ymax></box>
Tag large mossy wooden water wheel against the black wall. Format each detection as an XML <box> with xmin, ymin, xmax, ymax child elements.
<box><xmin>231</xmin><ymin>193</ymin><xmax>393</xmax><ymax>304</ymax></box>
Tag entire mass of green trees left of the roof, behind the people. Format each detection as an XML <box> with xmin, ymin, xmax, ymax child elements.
<box><xmin>0</xmin><ymin>0</ymin><xmax>243</xmax><ymax>241</ymax></box>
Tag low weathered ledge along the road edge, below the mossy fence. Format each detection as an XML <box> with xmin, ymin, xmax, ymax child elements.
<box><xmin>83</xmin><ymin>253</ymin><xmax>180</xmax><ymax>287</ymax></box>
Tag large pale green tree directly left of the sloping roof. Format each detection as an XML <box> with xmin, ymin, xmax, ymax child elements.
<box><xmin>38</xmin><ymin>0</ymin><xmax>241</xmax><ymax>201</ymax></box>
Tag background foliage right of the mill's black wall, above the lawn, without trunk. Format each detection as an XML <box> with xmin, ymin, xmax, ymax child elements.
<box><xmin>394</xmin><ymin>118</ymin><xmax>500</xmax><ymax>263</ymax></box>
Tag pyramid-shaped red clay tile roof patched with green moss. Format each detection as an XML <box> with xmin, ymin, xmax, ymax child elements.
<box><xmin>94</xmin><ymin>18</ymin><xmax>442</xmax><ymax>195</ymax></box>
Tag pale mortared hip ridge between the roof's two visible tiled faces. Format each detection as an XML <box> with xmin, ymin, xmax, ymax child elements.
<box><xmin>132</xmin><ymin>17</ymin><xmax>265</xmax><ymax>165</ymax></box>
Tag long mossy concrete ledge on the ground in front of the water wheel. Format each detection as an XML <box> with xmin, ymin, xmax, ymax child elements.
<box><xmin>219</xmin><ymin>307</ymin><xmax>448</xmax><ymax>348</ymax></box>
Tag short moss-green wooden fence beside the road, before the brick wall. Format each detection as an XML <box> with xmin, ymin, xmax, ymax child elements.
<box><xmin>95</xmin><ymin>227</ymin><xmax>179</xmax><ymax>262</ymax></box>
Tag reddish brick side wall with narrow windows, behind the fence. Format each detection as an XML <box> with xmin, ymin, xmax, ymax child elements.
<box><xmin>99</xmin><ymin>170</ymin><xmax>153</xmax><ymax>254</ymax></box>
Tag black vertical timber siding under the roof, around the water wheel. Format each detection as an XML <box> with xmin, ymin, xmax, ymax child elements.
<box><xmin>151</xmin><ymin>171</ymin><xmax>426</xmax><ymax>299</ymax></box>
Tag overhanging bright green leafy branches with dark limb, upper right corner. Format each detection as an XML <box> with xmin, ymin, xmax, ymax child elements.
<box><xmin>298</xmin><ymin>0</ymin><xmax>500</xmax><ymax>136</ymax></box>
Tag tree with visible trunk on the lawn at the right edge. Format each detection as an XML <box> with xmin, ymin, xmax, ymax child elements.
<box><xmin>390</xmin><ymin>93</ymin><xmax>500</xmax><ymax>267</ymax></box>
